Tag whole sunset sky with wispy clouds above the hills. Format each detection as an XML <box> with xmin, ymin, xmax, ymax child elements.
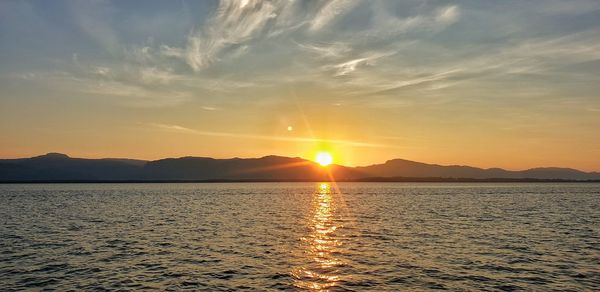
<box><xmin>0</xmin><ymin>0</ymin><xmax>600</xmax><ymax>171</ymax></box>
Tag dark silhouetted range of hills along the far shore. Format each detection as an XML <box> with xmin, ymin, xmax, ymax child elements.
<box><xmin>0</xmin><ymin>153</ymin><xmax>600</xmax><ymax>182</ymax></box>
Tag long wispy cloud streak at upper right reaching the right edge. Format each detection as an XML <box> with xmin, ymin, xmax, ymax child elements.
<box><xmin>312</xmin><ymin>23</ymin><xmax>600</xmax><ymax>98</ymax></box>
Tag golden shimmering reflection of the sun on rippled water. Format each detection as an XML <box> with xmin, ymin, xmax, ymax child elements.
<box><xmin>292</xmin><ymin>183</ymin><xmax>344</xmax><ymax>291</ymax></box>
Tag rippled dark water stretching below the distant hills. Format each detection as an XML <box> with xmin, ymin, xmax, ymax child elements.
<box><xmin>0</xmin><ymin>183</ymin><xmax>600</xmax><ymax>291</ymax></box>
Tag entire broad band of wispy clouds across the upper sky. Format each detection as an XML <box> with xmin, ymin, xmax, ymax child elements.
<box><xmin>7</xmin><ymin>0</ymin><xmax>600</xmax><ymax>110</ymax></box>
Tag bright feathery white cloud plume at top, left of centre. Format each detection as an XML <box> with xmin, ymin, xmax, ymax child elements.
<box><xmin>166</xmin><ymin>0</ymin><xmax>357</xmax><ymax>72</ymax></box>
